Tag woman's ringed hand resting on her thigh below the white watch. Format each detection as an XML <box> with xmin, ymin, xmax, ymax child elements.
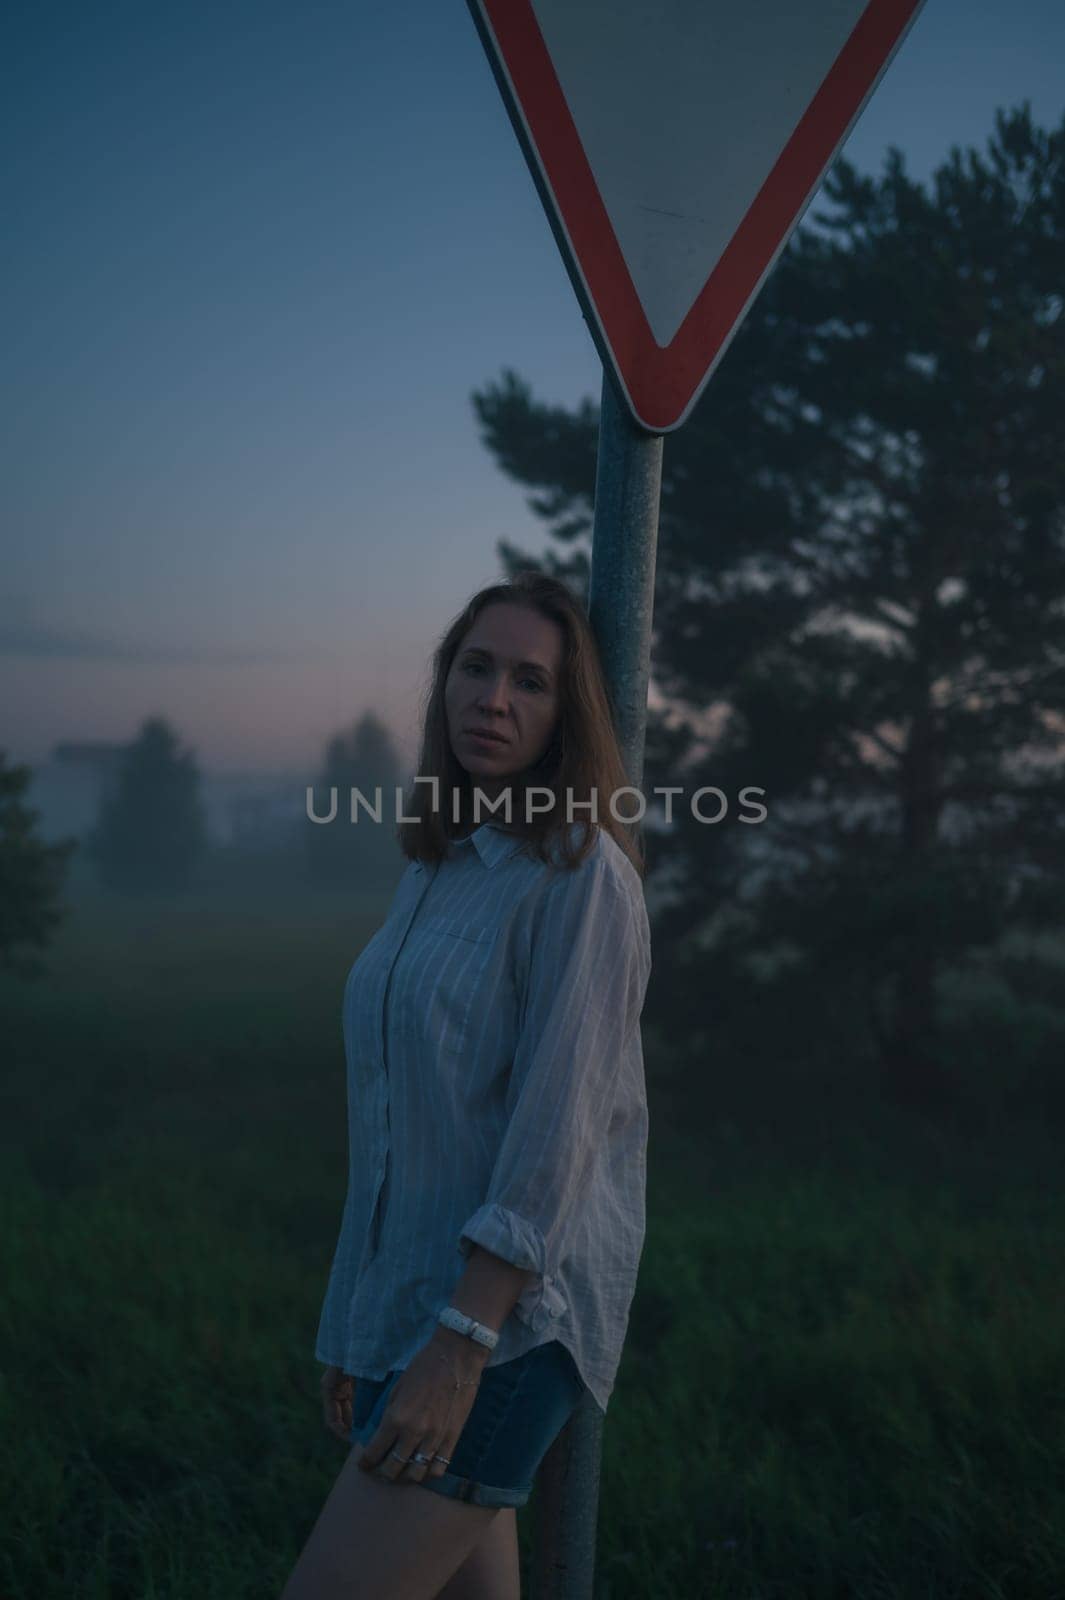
<box><xmin>358</xmin><ymin>1334</ymin><xmax>488</xmax><ymax>1483</ymax></box>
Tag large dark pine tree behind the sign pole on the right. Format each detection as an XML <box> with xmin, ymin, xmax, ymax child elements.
<box><xmin>473</xmin><ymin>104</ymin><xmax>1065</xmax><ymax>1104</ymax></box>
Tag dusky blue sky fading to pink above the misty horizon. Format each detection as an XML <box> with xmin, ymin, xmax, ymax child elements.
<box><xmin>8</xmin><ymin>0</ymin><xmax>1065</xmax><ymax>774</ymax></box>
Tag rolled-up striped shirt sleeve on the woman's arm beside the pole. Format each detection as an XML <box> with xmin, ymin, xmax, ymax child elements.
<box><xmin>459</xmin><ymin>858</ymin><xmax>651</xmax><ymax>1330</ymax></box>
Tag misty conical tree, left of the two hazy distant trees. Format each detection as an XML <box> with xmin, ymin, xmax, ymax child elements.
<box><xmin>88</xmin><ymin>717</ymin><xmax>206</xmax><ymax>893</ymax></box>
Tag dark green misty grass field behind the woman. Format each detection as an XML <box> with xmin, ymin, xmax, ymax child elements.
<box><xmin>0</xmin><ymin>888</ymin><xmax>1065</xmax><ymax>1600</ymax></box>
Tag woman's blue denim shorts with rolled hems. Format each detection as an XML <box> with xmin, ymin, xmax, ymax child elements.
<box><xmin>350</xmin><ymin>1339</ymin><xmax>585</xmax><ymax>1506</ymax></box>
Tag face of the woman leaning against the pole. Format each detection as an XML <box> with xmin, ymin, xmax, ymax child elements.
<box><xmin>445</xmin><ymin>600</ymin><xmax>564</xmax><ymax>810</ymax></box>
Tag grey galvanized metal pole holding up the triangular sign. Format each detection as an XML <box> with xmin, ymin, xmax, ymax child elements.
<box><xmin>531</xmin><ymin>370</ymin><xmax>662</xmax><ymax>1600</ymax></box>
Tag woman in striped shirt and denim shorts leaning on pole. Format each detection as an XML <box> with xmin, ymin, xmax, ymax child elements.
<box><xmin>283</xmin><ymin>573</ymin><xmax>651</xmax><ymax>1600</ymax></box>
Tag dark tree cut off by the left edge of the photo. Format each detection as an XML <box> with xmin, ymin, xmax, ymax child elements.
<box><xmin>0</xmin><ymin>750</ymin><xmax>77</xmax><ymax>978</ymax></box>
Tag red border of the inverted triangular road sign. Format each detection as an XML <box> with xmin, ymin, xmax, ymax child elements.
<box><xmin>481</xmin><ymin>0</ymin><xmax>923</xmax><ymax>432</ymax></box>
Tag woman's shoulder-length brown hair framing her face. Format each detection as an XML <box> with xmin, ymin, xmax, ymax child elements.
<box><xmin>397</xmin><ymin>571</ymin><xmax>644</xmax><ymax>878</ymax></box>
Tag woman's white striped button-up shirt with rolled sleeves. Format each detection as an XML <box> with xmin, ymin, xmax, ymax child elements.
<box><xmin>315</xmin><ymin>822</ymin><xmax>651</xmax><ymax>1411</ymax></box>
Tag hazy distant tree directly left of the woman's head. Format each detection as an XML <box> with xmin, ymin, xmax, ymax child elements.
<box><xmin>305</xmin><ymin>712</ymin><xmax>403</xmax><ymax>888</ymax></box>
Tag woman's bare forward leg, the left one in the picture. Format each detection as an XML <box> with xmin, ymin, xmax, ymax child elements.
<box><xmin>281</xmin><ymin>1445</ymin><xmax>499</xmax><ymax>1600</ymax></box>
